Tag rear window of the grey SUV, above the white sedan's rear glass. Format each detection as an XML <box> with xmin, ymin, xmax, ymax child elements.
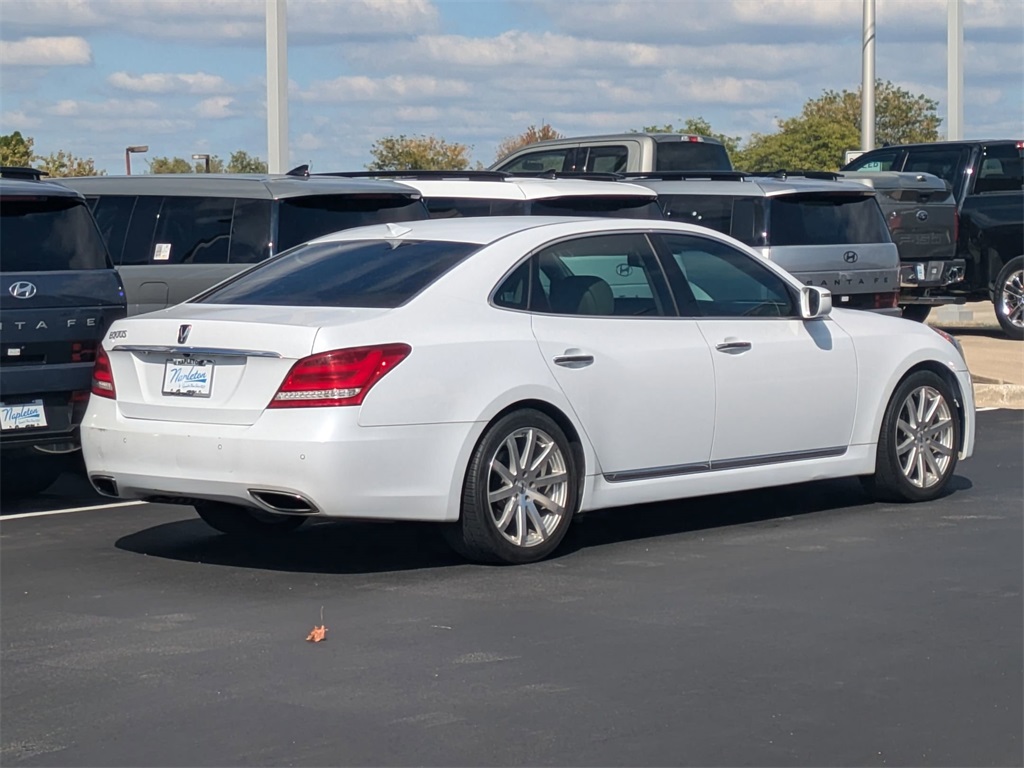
<box><xmin>278</xmin><ymin>195</ymin><xmax>427</xmax><ymax>252</ymax></box>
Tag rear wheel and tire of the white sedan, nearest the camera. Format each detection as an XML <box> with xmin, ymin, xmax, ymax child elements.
<box><xmin>444</xmin><ymin>409</ymin><xmax>580</xmax><ymax>564</ymax></box>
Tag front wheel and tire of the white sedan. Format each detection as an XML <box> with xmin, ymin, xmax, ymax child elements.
<box><xmin>864</xmin><ymin>371</ymin><xmax>961</xmax><ymax>502</ymax></box>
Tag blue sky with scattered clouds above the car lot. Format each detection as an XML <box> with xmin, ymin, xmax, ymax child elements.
<box><xmin>0</xmin><ymin>0</ymin><xmax>1024</xmax><ymax>173</ymax></box>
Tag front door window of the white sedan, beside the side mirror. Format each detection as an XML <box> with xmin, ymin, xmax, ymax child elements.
<box><xmin>662</xmin><ymin>234</ymin><xmax>797</xmax><ymax>317</ymax></box>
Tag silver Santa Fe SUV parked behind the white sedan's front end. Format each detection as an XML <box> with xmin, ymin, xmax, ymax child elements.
<box><xmin>628</xmin><ymin>172</ymin><xmax>900</xmax><ymax>316</ymax></box>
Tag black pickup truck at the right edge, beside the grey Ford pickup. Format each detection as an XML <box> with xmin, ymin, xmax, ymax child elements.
<box><xmin>843</xmin><ymin>139</ymin><xmax>1024</xmax><ymax>339</ymax></box>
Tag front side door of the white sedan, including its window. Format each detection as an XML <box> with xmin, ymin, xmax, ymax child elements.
<box><xmin>660</xmin><ymin>234</ymin><xmax>857</xmax><ymax>469</ymax></box>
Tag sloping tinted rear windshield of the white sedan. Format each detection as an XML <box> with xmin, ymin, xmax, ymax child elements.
<box><xmin>198</xmin><ymin>240</ymin><xmax>479</xmax><ymax>308</ymax></box>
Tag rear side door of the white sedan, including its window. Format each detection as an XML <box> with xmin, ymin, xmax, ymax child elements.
<box><xmin>520</xmin><ymin>233</ymin><xmax>715</xmax><ymax>480</ymax></box>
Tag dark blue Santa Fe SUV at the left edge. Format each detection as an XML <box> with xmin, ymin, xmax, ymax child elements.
<box><xmin>0</xmin><ymin>168</ymin><xmax>126</xmax><ymax>497</ymax></box>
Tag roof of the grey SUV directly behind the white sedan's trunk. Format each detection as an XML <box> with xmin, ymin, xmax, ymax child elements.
<box><xmin>62</xmin><ymin>173</ymin><xmax>419</xmax><ymax>200</ymax></box>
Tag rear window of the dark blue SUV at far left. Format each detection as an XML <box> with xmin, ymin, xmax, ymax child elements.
<box><xmin>0</xmin><ymin>197</ymin><xmax>111</xmax><ymax>272</ymax></box>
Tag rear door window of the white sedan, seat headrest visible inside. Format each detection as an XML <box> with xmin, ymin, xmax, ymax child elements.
<box><xmin>520</xmin><ymin>233</ymin><xmax>675</xmax><ymax>317</ymax></box>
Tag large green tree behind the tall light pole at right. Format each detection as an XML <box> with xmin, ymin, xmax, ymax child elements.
<box><xmin>733</xmin><ymin>81</ymin><xmax>942</xmax><ymax>171</ymax></box>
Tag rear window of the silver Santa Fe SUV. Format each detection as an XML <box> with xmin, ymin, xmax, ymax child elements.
<box><xmin>768</xmin><ymin>195</ymin><xmax>892</xmax><ymax>246</ymax></box>
